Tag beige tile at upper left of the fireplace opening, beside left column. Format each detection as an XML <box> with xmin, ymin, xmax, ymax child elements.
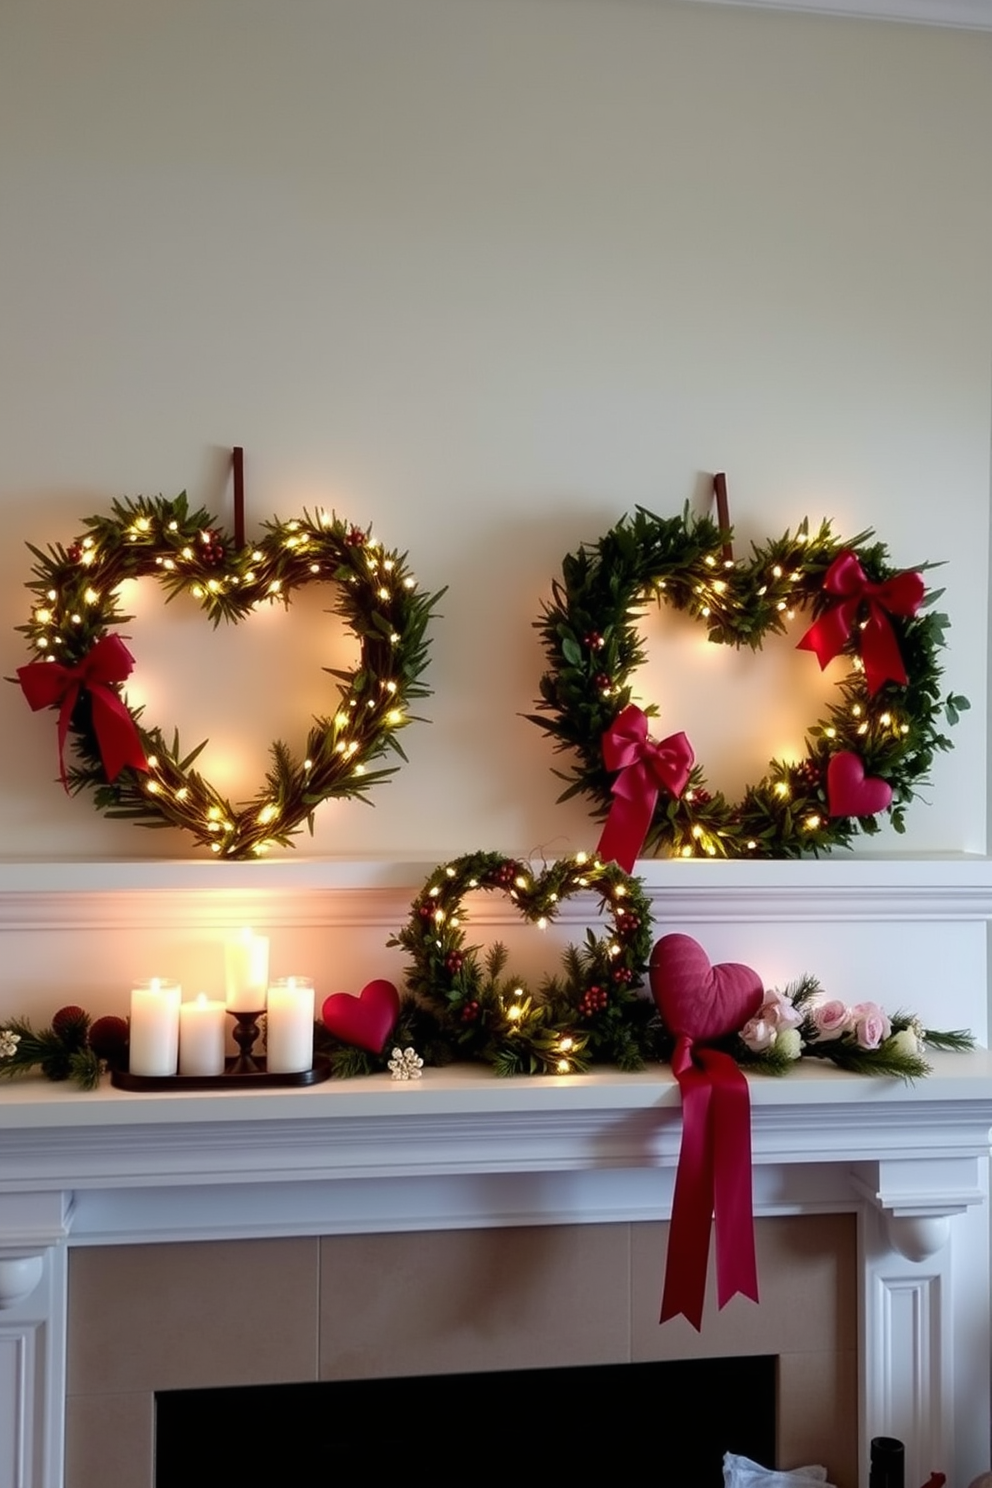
<box><xmin>68</xmin><ymin>1238</ymin><xmax>318</xmax><ymax>1396</ymax></box>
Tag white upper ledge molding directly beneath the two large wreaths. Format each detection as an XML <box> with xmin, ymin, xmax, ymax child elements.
<box><xmin>0</xmin><ymin>863</ymin><xmax>992</xmax><ymax>933</ymax></box>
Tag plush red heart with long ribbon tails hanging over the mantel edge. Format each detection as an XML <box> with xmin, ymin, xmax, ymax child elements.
<box><xmin>650</xmin><ymin>934</ymin><xmax>764</xmax><ymax>1329</ymax></box>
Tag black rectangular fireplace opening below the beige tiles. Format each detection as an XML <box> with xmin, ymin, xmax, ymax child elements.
<box><xmin>155</xmin><ymin>1356</ymin><xmax>776</xmax><ymax>1488</ymax></box>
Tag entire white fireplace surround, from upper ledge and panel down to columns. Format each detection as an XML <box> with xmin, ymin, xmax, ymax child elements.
<box><xmin>0</xmin><ymin>860</ymin><xmax>992</xmax><ymax>1488</ymax></box>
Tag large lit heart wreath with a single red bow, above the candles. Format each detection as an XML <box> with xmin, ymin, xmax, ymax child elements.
<box><xmin>18</xmin><ymin>493</ymin><xmax>443</xmax><ymax>859</ymax></box>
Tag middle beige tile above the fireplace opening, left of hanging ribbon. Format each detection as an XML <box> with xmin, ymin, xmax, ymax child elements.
<box><xmin>320</xmin><ymin>1225</ymin><xmax>631</xmax><ymax>1379</ymax></box>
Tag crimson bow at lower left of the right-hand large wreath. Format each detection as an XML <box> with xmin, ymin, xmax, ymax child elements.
<box><xmin>596</xmin><ymin>702</ymin><xmax>696</xmax><ymax>873</ymax></box>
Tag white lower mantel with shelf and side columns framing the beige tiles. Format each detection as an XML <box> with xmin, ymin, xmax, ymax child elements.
<box><xmin>0</xmin><ymin>1051</ymin><xmax>992</xmax><ymax>1488</ymax></box>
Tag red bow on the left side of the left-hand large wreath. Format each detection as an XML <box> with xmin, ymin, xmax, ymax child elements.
<box><xmin>18</xmin><ymin>635</ymin><xmax>149</xmax><ymax>790</ymax></box>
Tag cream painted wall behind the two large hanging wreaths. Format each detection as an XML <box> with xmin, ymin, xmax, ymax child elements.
<box><xmin>0</xmin><ymin>0</ymin><xmax>992</xmax><ymax>860</ymax></box>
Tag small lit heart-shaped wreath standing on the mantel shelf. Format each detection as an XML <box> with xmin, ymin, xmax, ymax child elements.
<box><xmin>390</xmin><ymin>853</ymin><xmax>656</xmax><ymax>1074</ymax></box>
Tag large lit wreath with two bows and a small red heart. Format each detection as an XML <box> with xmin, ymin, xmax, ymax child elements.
<box><xmin>529</xmin><ymin>507</ymin><xmax>968</xmax><ymax>868</ymax></box>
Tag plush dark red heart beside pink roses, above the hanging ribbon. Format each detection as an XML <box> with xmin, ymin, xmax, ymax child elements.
<box><xmin>651</xmin><ymin>934</ymin><xmax>764</xmax><ymax>1043</ymax></box>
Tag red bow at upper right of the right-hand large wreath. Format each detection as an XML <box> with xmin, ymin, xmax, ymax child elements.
<box><xmin>796</xmin><ymin>548</ymin><xmax>927</xmax><ymax>693</ymax></box>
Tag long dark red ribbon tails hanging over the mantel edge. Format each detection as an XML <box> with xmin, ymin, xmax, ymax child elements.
<box><xmin>660</xmin><ymin>1037</ymin><xmax>759</xmax><ymax>1332</ymax></box>
